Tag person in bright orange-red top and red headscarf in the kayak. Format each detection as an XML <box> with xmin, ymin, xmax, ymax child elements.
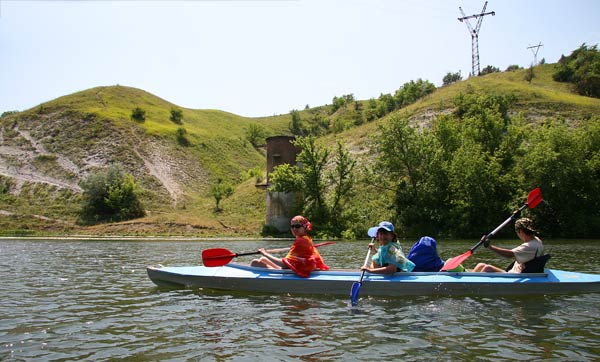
<box><xmin>250</xmin><ymin>215</ymin><xmax>329</xmax><ymax>278</ymax></box>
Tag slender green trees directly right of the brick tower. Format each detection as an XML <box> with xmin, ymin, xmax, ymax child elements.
<box><xmin>270</xmin><ymin>137</ymin><xmax>356</xmax><ymax>237</ymax></box>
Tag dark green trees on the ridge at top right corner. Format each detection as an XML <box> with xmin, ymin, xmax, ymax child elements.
<box><xmin>553</xmin><ymin>44</ymin><xmax>600</xmax><ymax>98</ymax></box>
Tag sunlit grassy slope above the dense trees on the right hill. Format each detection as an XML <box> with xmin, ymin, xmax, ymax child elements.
<box><xmin>324</xmin><ymin>64</ymin><xmax>600</xmax><ymax>156</ymax></box>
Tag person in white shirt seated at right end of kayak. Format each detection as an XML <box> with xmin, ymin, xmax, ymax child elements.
<box><xmin>473</xmin><ymin>217</ymin><xmax>544</xmax><ymax>273</ymax></box>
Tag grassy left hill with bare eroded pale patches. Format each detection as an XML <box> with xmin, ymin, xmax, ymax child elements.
<box><xmin>0</xmin><ymin>86</ymin><xmax>289</xmax><ymax>235</ymax></box>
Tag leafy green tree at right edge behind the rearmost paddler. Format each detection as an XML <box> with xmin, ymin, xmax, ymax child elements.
<box><xmin>517</xmin><ymin>118</ymin><xmax>600</xmax><ymax>237</ymax></box>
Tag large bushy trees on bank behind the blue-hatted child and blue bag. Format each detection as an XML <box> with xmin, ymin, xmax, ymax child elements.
<box><xmin>373</xmin><ymin>94</ymin><xmax>522</xmax><ymax>236</ymax></box>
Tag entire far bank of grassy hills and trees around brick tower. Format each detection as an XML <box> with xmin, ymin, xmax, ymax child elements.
<box><xmin>0</xmin><ymin>46</ymin><xmax>600</xmax><ymax>238</ymax></box>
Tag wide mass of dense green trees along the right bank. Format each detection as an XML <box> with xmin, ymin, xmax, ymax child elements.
<box><xmin>376</xmin><ymin>94</ymin><xmax>600</xmax><ymax>237</ymax></box>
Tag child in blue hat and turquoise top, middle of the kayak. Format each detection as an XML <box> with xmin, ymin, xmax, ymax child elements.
<box><xmin>361</xmin><ymin>221</ymin><xmax>415</xmax><ymax>274</ymax></box>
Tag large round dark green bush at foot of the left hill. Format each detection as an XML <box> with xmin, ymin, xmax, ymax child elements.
<box><xmin>80</xmin><ymin>165</ymin><xmax>145</xmax><ymax>223</ymax></box>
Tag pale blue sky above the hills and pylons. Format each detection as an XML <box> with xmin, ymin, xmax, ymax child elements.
<box><xmin>0</xmin><ymin>0</ymin><xmax>600</xmax><ymax>117</ymax></box>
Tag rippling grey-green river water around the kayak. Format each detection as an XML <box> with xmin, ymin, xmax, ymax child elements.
<box><xmin>0</xmin><ymin>239</ymin><xmax>600</xmax><ymax>361</ymax></box>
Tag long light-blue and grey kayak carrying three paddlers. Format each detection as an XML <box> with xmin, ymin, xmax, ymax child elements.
<box><xmin>147</xmin><ymin>263</ymin><xmax>600</xmax><ymax>296</ymax></box>
